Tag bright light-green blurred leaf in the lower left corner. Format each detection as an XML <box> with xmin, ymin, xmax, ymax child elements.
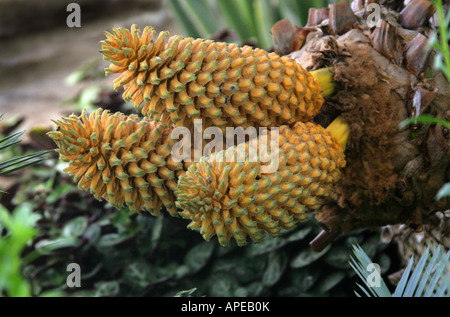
<box><xmin>0</xmin><ymin>204</ymin><xmax>39</xmax><ymax>297</ymax></box>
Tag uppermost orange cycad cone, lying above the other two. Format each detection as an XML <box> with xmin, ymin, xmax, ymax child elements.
<box><xmin>101</xmin><ymin>25</ymin><xmax>329</xmax><ymax>128</ymax></box>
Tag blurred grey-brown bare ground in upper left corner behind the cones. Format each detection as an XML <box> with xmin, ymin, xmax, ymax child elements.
<box><xmin>0</xmin><ymin>0</ymin><xmax>179</xmax><ymax>129</ymax></box>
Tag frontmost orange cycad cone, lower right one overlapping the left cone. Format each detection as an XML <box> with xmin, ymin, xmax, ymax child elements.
<box><xmin>175</xmin><ymin>119</ymin><xmax>345</xmax><ymax>246</ymax></box>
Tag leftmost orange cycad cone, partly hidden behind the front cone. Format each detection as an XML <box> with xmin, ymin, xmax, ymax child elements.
<box><xmin>49</xmin><ymin>109</ymin><xmax>188</xmax><ymax>216</ymax></box>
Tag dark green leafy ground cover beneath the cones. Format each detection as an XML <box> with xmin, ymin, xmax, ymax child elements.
<box><xmin>1</xmin><ymin>143</ymin><xmax>398</xmax><ymax>297</ymax></box>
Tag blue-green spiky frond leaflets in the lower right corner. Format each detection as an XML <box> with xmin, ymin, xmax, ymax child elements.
<box><xmin>350</xmin><ymin>245</ymin><xmax>450</xmax><ymax>297</ymax></box>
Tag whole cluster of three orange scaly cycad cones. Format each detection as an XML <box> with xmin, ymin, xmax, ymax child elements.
<box><xmin>49</xmin><ymin>26</ymin><xmax>348</xmax><ymax>246</ymax></box>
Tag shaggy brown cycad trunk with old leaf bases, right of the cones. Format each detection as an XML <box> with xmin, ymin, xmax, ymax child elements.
<box><xmin>272</xmin><ymin>0</ymin><xmax>450</xmax><ymax>249</ymax></box>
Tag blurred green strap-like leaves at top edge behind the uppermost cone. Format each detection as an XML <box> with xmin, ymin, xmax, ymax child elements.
<box><xmin>166</xmin><ymin>0</ymin><xmax>328</xmax><ymax>49</ymax></box>
